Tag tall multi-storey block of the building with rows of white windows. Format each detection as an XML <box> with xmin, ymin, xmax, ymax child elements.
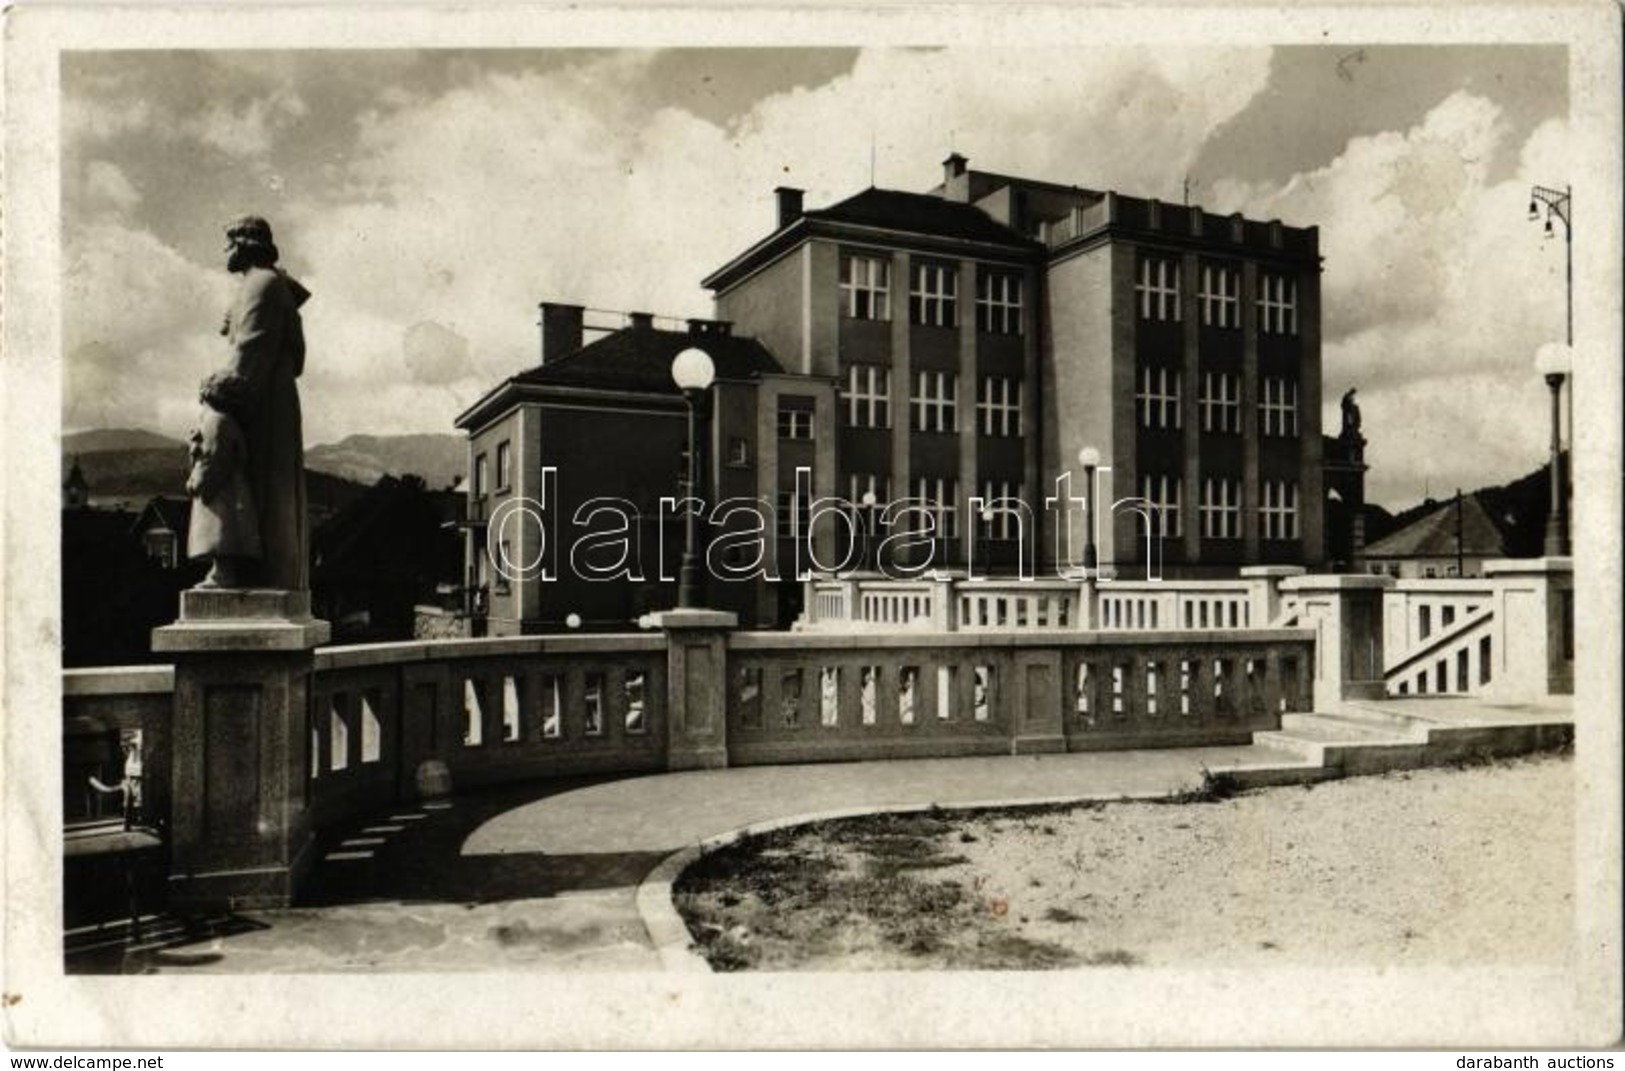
<box><xmin>705</xmin><ymin>154</ymin><xmax>1326</xmax><ymax>575</ymax></box>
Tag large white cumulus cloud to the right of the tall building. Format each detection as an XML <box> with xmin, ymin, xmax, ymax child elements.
<box><xmin>1217</xmin><ymin>93</ymin><xmax>1565</xmax><ymax>504</ymax></box>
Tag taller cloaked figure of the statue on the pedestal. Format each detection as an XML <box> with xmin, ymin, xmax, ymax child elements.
<box><xmin>221</xmin><ymin>216</ymin><xmax>310</xmax><ymax>592</ymax></box>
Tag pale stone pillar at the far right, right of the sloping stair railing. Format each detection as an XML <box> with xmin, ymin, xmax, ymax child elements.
<box><xmin>1484</xmin><ymin>557</ymin><xmax>1575</xmax><ymax>699</ymax></box>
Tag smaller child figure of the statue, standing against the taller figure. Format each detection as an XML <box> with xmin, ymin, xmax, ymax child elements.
<box><xmin>187</xmin><ymin>372</ymin><xmax>263</xmax><ymax>588</ymax></box>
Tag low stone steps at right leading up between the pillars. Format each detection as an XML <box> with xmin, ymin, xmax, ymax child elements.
<box><xmin>1216</xmin><ymin>697</ymin><xmax>1573</xmax><ymax>787</ymax></box>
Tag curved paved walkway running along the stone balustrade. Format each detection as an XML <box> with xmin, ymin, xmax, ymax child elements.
<box><xmin>70</xmin><ymin>700</ymin><xmax>1568</xmax><ymax>973</ymax></box>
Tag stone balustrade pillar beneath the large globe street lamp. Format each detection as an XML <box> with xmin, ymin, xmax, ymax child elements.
<box><xmin>655</xmin><ymin>609</ymin><xmax>739</xmax><ymax>770</ymax></box>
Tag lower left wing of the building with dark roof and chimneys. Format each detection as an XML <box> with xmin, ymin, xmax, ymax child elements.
<box><xmin>457</xmin><ymin>310</ymin><xmax>837</xmax><ymax>635</ymax></box>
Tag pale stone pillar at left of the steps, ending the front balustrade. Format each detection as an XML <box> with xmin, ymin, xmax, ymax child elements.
<box><xmin>1281</xmin><ymin>575</ymin><xmax>1394</xmax><ymax>712</ymax></box>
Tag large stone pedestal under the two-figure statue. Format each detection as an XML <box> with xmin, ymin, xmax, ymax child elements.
<box><xmin>153</xmin><ymin>588</ymin><xmax>328</xmax><ymax>912</ymax></box>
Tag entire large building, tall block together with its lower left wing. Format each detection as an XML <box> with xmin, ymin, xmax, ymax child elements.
<box><xmin>457</xmin><ymin>154</ymin><xmax>1326</xmax><ymax>634</ymax></box>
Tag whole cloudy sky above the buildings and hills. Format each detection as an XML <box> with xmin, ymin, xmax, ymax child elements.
<box><xmin>62</xmin><ymin>46</ymin><xmax>1568</xmax><ymax>509</ymax></box>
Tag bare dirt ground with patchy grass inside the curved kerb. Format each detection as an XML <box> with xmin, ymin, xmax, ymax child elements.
<box><xmin>674</xmin><ymin>756</ymin><xmax>1575</xmax><ymax>970</ymax></box>
